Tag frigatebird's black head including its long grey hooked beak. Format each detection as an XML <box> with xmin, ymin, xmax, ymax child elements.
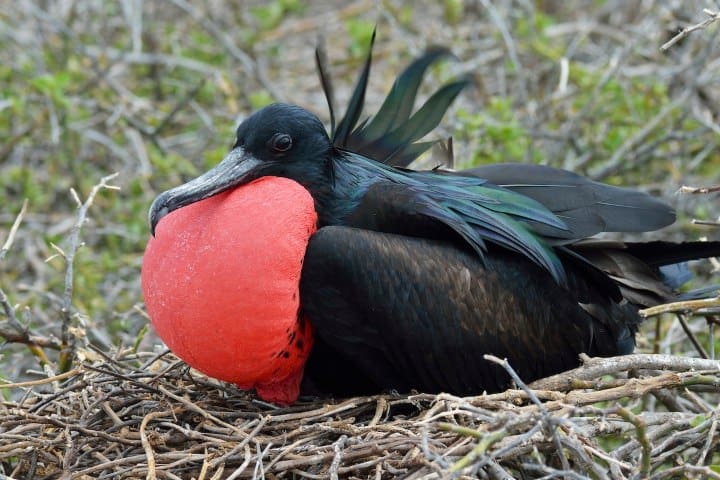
<box><xmin>148</xmin><ymin>103</ymin><xmax>333</xmax><ymax>235</ymax></box>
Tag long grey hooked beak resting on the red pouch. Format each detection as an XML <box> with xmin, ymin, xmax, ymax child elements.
<box><xmin>148</xmin><ymin>147</ymin><xmax>261</xmax><ymax>236</ymax></box>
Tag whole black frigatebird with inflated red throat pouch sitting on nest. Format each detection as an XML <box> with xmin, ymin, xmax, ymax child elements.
<box><xmin>141</xmin><ymin>31</ymin><xmax>720</xmax><ymax>404</ymax></box>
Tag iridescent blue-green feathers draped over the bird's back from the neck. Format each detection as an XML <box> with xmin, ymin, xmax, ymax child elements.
<box><xmin>330</xmin><ymin>154</ymin><xmax>566</xmax><ymax>284</ymax></box>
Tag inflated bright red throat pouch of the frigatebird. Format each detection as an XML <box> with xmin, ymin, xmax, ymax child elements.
<box><xmin>141</xmin><ymin>177</ymin><xmax>317</xmax><ymax>404</ymax></box>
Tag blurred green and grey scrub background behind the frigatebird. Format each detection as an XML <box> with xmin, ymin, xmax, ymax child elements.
<box><xmin>0</xmin><ymin>0</ymin><xmax>720</xmax><ymax>380</ymax></box>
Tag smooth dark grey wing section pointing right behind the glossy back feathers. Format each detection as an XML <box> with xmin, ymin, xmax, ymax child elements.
<box><xmin>452</xmin><ymin>163</ymin><xmax>675</xmax><ymax>243</ymax></box>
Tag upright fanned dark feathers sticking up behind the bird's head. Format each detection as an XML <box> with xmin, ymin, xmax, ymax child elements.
<box><xmin>315</xmin><ymin>32</ymin><xmax>470</xmax><ymax>167</ymax></box>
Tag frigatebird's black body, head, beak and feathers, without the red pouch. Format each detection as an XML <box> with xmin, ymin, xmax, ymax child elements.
<box><xmin>150</xmin><ymin>35</ymin><xmax>720</xmax><ymax>394</ymax></box>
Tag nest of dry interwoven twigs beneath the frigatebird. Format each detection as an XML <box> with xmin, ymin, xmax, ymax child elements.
<box><xmin>0</xmin><ymin>353</ymin><xmax>720</xmax><ymax>479</ymax></box>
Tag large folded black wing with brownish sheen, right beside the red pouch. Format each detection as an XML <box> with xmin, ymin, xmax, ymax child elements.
<box><xmin>300</xmin><ymin>226</ymin><xmax>637</xmax><ymax>394</ymax></box>
